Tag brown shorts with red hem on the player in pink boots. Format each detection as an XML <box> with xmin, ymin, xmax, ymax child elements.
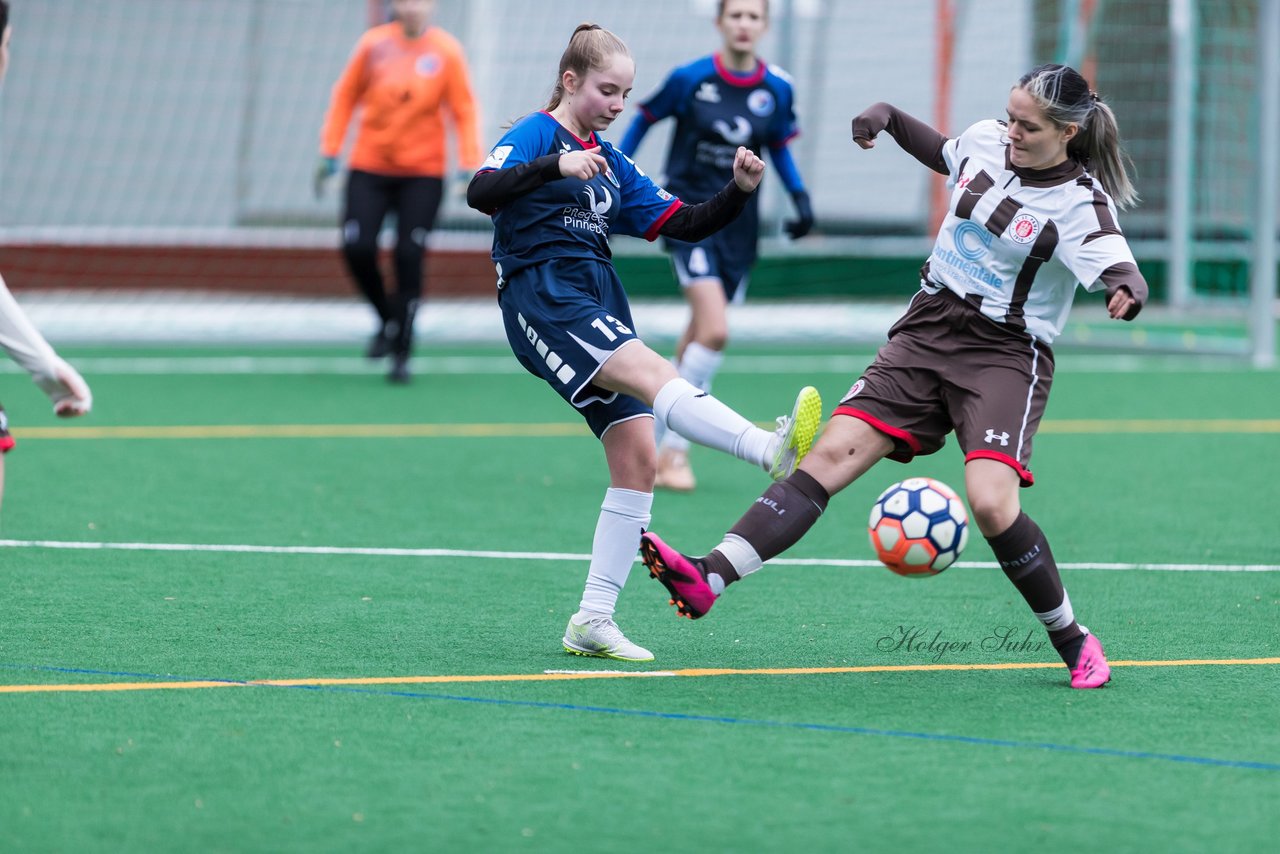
<box><xmin>835</xmin><ymin>291</ymin><xmax>1053</xmax><ymax>487</ymax></box>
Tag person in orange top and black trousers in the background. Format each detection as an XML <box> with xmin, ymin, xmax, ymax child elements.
<box><xmin>315</xmin><ymin>0</ymin><xmax>481</xmax><ymax>383</ymax></box>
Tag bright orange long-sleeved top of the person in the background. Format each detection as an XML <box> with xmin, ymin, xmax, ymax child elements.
<box><xmin>320</xmin><ymin>23</ymin><xmax>481</xmax><ymax>177</ymax></box>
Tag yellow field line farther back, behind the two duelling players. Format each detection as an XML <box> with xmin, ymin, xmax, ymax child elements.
<box><xmin>13</xmin><ymin>419</ymin><xmax>1280</xmax><ymax>439</ymax></box>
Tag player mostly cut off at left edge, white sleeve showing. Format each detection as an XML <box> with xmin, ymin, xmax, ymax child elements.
<box><xmin>0</xmin><ymin>0</ymin><xmax>93</xmax><ymax>512</ymax></box>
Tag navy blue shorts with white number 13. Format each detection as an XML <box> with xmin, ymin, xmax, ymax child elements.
<box><xmin>498</xmin><ymin>259</ymin><xmax>653</xmax><ymax>437</ymax></box>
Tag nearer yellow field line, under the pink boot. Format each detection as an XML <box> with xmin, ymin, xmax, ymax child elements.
<box><xmin>0</xmin><ymin>658</ymin><xmax>1280</xmax><ymax>694</ymax></box>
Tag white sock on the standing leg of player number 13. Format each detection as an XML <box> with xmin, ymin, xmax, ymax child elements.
<box><xmin>579</xmin><ymin>488</ymin><xmax>653</xmax><ymax>617</ymax></box>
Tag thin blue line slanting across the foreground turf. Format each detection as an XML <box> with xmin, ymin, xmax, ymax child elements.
<box><xmin>10</xmin><ymin>663</ymin><xmax>1280</xmax><ymax>771</ymax></box>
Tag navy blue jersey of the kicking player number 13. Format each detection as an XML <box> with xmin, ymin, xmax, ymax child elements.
<box><xmin>479</xmin><ymin>113</ymin><xmax>680</xmax><ymax>279</ymax></box>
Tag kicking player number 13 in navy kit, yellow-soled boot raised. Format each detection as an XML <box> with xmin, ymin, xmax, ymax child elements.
<box><xmin>467</xmin><ymin>24</ymin><xmax>822</xmax><ymax>661</ymax></box>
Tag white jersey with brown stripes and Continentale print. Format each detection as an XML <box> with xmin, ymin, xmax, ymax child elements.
<box><xmin>920</xmin><ymin>119</ymin><xmax>1147</xmax><ymax>344</ymax></box>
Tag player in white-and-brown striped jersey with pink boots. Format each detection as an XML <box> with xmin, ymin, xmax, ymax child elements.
<box><xmin>641</xmin><ymin>65</ymin><xmax>1147</xmax><ymax>688</ymax></box>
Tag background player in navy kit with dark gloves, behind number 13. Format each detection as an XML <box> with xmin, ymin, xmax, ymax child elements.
<box><xmin>618</xmin><ymin>0</ymin><xmax>813</xmax><ymax>492</ymax></box>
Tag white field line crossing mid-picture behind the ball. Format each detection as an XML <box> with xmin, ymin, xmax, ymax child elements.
<box><xmin>0</xmin><ymin>539</ymin><xmax>1280</xmax><ymax>572</ymax></box>
